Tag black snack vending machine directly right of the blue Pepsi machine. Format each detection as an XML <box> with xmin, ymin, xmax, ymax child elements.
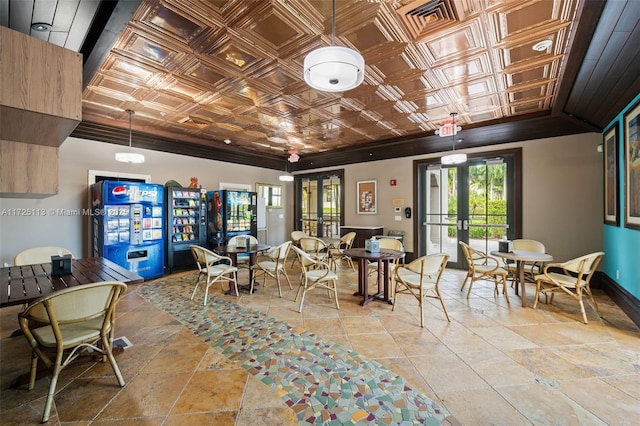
<box><xmin>165</xmin><ymin>188</ymin><xmax>207</xmax><ymax>272</ymax></box>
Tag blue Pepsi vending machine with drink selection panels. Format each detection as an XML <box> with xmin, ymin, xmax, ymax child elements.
<box><xmin>91</xmin><ymin>180</ymin><xmax>164</xmax><ymax>279</ymax></box>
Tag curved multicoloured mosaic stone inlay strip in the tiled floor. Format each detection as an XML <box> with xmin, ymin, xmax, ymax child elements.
<box><xmin>138</xmin><ymin>274</ymin><xmax>449</xmax><ymax>425</ymax></box>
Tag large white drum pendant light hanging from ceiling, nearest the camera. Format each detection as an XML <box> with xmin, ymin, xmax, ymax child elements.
<box><xmin>304</xmin><ymin>0</ymin><xmax>364</xmax><ymax>92</ymax></box>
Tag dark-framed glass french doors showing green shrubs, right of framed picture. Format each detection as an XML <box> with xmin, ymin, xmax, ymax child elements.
<box><xmin>418</xmin><ymin>151</ymin><xmax>522</xmax><ymax>269</ymax></box>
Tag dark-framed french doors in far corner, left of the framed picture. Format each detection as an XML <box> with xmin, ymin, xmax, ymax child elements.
<box><xmin>295</xmin><ymin>170</ymin><xmax>344</xmax><ymax>237</ymax></box>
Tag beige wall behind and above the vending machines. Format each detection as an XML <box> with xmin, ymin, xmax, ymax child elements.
<box><xmin>0</xmin><ymin>138</ymin><xmax>293</xmax><ymax>265</ymax></box>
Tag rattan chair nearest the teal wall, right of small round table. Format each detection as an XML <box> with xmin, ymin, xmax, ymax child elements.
<box><xmin>533</xmin><ymin>251</ymin><xmax>604</xmax><ymax>324</ymax></box>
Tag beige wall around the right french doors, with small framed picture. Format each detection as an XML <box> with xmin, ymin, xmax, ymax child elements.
<box><xmin>305</xmin><ymin>133</ymin><xmax>603</xmax><ymax>260</ymax></box>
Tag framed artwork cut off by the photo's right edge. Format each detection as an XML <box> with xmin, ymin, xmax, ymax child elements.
<box><xmin>624</xmin><ymin>101</ymin><xmax>640</xmax><ymax>229</ymax></box>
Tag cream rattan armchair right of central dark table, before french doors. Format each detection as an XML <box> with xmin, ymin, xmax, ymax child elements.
<box><xmin>391</xmin><ymin>253</ymin><xmax>451</xmax><ymax>327</ymax></box>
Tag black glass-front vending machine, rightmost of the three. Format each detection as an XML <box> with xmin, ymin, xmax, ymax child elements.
<box><xmin>207</xmin><ymin>190</ymin><xmax>258</xmax><ymax>248</ymax></box>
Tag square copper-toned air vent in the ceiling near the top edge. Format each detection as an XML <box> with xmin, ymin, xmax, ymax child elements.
<box><xmin>396</xmin><ymin>0</ymin><xmax>465</xmax><ymax>41</ymax></box>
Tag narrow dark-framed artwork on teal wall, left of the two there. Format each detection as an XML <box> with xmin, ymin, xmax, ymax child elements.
<box><xmin>603</xmin><ymin>121</ymin><xmax>620</xmax><ymax>226</ymax></box>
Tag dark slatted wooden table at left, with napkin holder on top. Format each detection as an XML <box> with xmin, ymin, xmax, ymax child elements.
<box><xmin>0</xmin><ymin>257</ymin><xmax>144</xmax><ymax>308</ymax></box>
